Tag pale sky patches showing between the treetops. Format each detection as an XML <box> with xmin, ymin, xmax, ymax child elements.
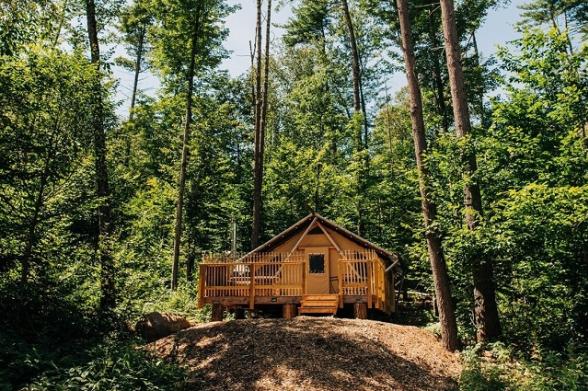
<box><xmin>114</xmin><ymin>0</ymin><xmax>525</xmax><ymax>117</ymax></box>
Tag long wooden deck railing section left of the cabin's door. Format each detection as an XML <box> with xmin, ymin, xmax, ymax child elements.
<box><xmin>198</xmin><ymin>252</ymin><xmax>304</xmax><ymax>308</ymax></box>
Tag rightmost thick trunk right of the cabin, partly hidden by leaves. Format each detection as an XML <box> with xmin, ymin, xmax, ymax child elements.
<box><xmin>441</xmin><ymin>0</ymin><xmax>500</xmax><ymax>342</ymax></box>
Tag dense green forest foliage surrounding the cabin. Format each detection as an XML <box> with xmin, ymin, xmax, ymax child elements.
<box><xmin>0</xmin><ymin>0</ymin><xmax>588</xmax><ymax>390</ymax></box>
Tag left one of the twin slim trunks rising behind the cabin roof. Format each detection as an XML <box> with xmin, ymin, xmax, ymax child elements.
<box><xmin>251</xmin><ymin>0</ymin><xmax>263</xmax><ymax>248</ymax></box>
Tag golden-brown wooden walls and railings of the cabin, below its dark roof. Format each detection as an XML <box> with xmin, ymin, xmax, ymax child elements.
<box><xmin>199</xmin><ymin>216</ymin><xmax>395</xmax><ymax>313</ymax></box>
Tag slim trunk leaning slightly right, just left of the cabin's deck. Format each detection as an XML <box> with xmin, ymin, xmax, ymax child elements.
<box><xmin>171</xmin><ymin>3</ymin><xmax>201</xmax><ymax>290</ymax></box>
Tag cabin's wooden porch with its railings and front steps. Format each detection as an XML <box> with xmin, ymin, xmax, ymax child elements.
<box><xmin>198</xmin><ymin>250</ymin><xmax>393</xmax><ymax>314</ymax></box>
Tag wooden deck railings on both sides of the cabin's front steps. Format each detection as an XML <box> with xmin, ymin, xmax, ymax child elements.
<box><xmin>198</xmin><ymin>250</ymin><xmax>387</xmax><ymax>309</ymax></box>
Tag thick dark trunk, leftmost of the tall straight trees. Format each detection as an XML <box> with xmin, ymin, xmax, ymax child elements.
<box><xmin>86</xmin><ymin>0</ymin><xmax>116</xmax><ymax>312</ymax></box>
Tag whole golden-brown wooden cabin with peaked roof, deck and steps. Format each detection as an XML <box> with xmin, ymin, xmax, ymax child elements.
<box><xmin>198</xmin><ymin>213</ymin><xmax>401</xmax><ymax>320</ymax></box>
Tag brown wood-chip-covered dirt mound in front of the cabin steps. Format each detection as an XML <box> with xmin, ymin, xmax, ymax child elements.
<box><xmin>148</xmin><ymin>317</ymin><xmax>461</xmax><ymax>391</ymax></box>
